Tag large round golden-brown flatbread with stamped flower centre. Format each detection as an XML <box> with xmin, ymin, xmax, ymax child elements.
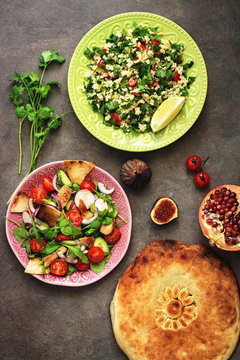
<box><xmin>110</xmin><ymin>240</ymin><xmax>240</xmax><ymax>360</ymax></box>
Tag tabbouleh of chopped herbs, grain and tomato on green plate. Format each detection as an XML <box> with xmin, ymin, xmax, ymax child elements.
<box><xmin>83</xmin><ymin>23</ymin><xmax>195</xmax><ymax>133</ymax></box>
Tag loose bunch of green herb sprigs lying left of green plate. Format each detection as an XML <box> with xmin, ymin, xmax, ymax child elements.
<box><xmin>10</xmin><ymin>50</ymin><xmax>70</xmax><ymax>184</ymax></box>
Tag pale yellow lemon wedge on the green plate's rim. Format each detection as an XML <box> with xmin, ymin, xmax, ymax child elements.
<box><xmin>150</xmin><ymin>96</ymin><xmax>185</xmax><ymax>132</ymax></box>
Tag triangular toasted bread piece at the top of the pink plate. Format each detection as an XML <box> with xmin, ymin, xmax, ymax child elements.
<box><xmin>64</xmin><ymin>160</ymin><xmax>95</xmax><ymax>185</ymax></box>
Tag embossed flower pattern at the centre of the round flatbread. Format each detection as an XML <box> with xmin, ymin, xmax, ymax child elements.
<box><xmin>155</xmin><ymin>285</ymin><xmax>197</xmax><ymax>330</ymax></box>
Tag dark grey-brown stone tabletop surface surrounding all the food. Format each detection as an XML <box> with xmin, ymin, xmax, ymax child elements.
<box><xmin>0</xmin><ymin>0</ymin><xmax>240</xmax><ymax>360</ymax></box>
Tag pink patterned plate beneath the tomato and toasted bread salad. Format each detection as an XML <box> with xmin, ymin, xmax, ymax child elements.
<box><xmin>6</xmin><ymin>161</ymin><xmax>132</xmax><ymax>286</ymax></box>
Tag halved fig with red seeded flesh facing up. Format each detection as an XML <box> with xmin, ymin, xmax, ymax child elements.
<box><xmin>151</xmin><ymin>197</ymin><xmax>178</xmax><ymax>225</ymax></box>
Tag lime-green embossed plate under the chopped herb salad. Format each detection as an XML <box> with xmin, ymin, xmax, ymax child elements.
<box><xmin>68</xmin><ymin>13</ymin><xmax>207</xmax><ymax>151</ymax></box>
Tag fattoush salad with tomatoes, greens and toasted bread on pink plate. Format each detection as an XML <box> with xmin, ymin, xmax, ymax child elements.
<box><xmin>9</xmin><ymin>160</ymin><xmax>127</xmax><ymax>276</ymax></box>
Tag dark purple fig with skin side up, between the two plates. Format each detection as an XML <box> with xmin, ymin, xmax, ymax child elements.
<box><xmin>120</xmin><ymin>159</ymin><xmax>152</xmax><ymax>188</ymax></box>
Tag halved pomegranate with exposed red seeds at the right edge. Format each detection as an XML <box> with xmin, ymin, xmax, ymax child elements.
<box><xmin>198</xmin><ymin>185</ymin><xmax>240</xmax><ymax>251</ymax></box>
